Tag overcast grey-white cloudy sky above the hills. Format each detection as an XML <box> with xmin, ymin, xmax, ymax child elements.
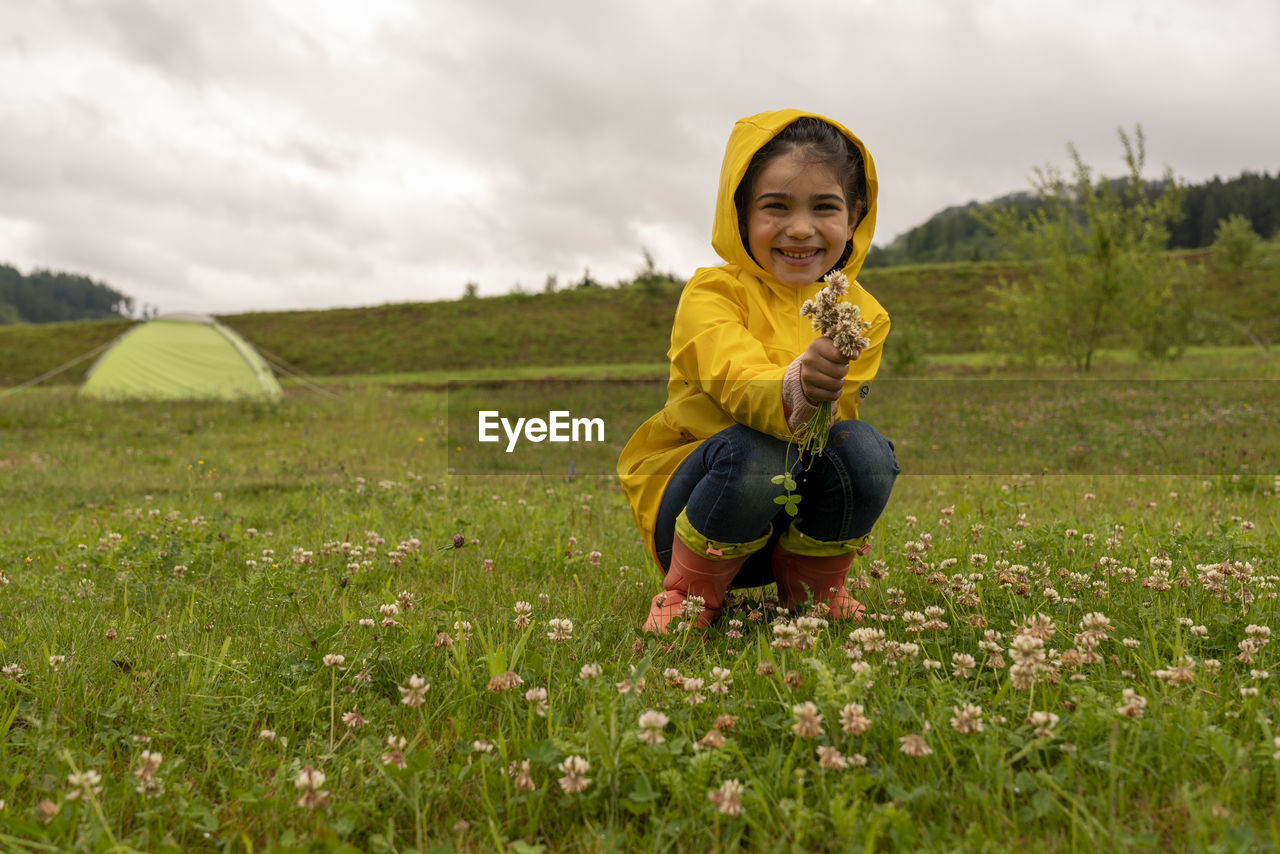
<box><xmin>0</xmin><ymin>0</ymin><xmax>1280</xmax><ymax>314</ymax></box>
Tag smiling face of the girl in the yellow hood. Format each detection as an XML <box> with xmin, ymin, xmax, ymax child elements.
<box><xmin>746</xmin><ymin>149</ymin><xmax>858</xmax><ymax>288</ymax></box>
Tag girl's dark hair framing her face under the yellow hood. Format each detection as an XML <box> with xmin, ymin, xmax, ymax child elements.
<box><xmin>733</xmin><ymin>115</ymin><xmax>867</xmax><ymax>270</ymax></box>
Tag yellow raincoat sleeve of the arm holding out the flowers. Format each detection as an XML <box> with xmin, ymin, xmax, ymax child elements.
<box><xmin>668</xmin><ymin>274</ymin><xmax>791</xmax><ymax>439</ymax></box>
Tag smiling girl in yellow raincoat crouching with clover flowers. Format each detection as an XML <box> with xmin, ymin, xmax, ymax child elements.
<box><xmin>618</xmin><ymin>110</ymin><xmax>899</xmax><ymax>634</ymax></box>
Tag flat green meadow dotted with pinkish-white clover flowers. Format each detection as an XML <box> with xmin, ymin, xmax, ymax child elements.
<box><xmin>0</xmin><ymin>350</ymin><xmax>1280</xmax><ymax>851</ymax></box>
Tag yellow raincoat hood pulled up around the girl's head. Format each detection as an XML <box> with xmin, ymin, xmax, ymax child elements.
<box><xmin>712</xmin><ymin>110</ymin><xmax>877</xmax><ymax>287</ymax></box>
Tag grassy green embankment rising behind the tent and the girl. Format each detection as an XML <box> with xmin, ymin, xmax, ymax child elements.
<box><xmin>0</xmin><ymin>252</ymin><xmax>1280</xmax><ymax>385</ymax></box>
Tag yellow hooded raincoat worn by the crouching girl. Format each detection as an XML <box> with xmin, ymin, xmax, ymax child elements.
<box><xmin>618</xmin><ymin>110</ymin><xmax>890</xmax><ymax>571</ymax></box>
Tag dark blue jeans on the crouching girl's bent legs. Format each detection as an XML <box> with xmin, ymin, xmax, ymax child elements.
<box><xmin>654</xmin><ymin>420</ymin><xmax>900</xmax><ymax>588</ymax></box>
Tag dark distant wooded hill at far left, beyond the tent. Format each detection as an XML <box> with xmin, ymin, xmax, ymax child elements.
<box><xmin>0</xmin><ymin>264</ymin><xmax>133</xmax><ymax>325</ymax></box>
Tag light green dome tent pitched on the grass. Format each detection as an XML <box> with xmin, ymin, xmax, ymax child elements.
<box><xmin>79</xmin><ymin>315</ymin><xmax>283</xmax><ymax>401</ymax></box>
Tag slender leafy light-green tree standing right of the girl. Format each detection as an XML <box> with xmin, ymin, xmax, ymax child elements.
<box><xmin>978</xmin><ymin>125</ymin><xmax>1190</xmax><ymax>371</ymax></box>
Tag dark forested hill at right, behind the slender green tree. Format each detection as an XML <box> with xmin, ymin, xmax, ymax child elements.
<box><xmin>865</xmin><ymin>172</ymin><xmax>1280</xmax><ymax>268</ymax></box>
